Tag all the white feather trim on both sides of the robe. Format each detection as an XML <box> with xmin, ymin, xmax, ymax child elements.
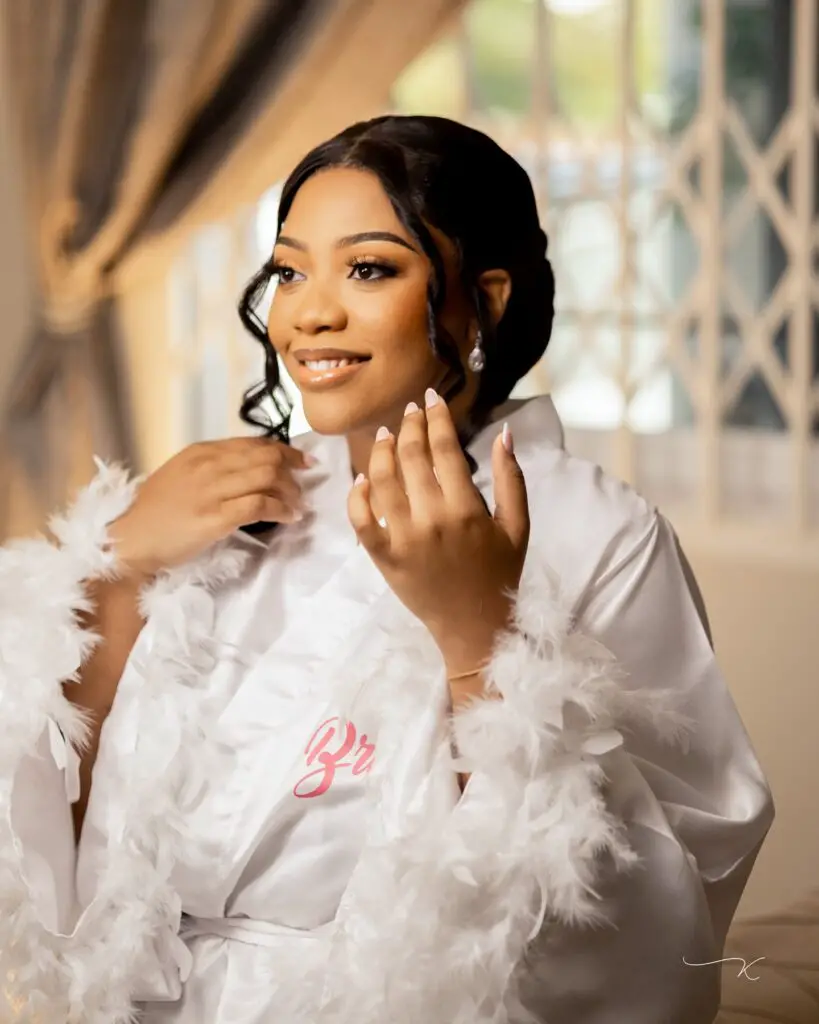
<box><xmin>0</xmin><ymin>464</ymin><xmax>688</xmax><ymax>1024</ymax></box>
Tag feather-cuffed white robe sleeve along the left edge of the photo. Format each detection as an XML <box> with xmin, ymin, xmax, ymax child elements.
<box><xmin>0</xmin><ymin>462</ymin><xmax>192</xmax><ymax>1024</ymax></box>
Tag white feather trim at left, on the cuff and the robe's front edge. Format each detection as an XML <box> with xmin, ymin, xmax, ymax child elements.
<box><xmin>0</xmin><ymin>461</ymin><xmax>247</xmax><ymax>1024</ymax></box>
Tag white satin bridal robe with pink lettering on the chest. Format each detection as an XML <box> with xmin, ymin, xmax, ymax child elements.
<box><xmin>0</xmin><ymin>397</ymin><xmax>773</xmax><ymax>1024</ymax></box>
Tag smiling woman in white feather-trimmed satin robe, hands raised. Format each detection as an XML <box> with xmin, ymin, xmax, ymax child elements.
<box><xmin>0</xmin><ymin>117</ymin><xmax>773</xmax><ymax>1024</ymax></box>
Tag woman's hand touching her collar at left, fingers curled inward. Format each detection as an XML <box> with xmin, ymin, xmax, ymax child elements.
<box><xmin>109</xmin><ymin>437</ymin><xmax>312</xmax><ymax>580</ymax></box>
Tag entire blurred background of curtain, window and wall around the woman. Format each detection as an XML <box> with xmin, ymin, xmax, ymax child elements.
<box><xmin>0</xmin><ymin>0</ymin><xmax>819</xmax><ymax>1020</ymax></box>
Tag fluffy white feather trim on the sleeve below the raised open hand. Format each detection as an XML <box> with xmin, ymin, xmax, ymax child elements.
<box><xmin>313</xmin><ymin>552</ymin><xmax>691</xmax><ymax>1024</ymax></box>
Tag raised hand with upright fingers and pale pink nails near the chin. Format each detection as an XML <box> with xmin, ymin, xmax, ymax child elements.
<box><xmin>347</xmin><ymin>392</ymin><xmax>529</xmax><ymax>673</ymax></box>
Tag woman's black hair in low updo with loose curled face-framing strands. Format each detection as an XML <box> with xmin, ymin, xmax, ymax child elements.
<box><xmin>239</xmin><ymin>115</ymin><xmax>555</xmax><ymax>532</ymax></box>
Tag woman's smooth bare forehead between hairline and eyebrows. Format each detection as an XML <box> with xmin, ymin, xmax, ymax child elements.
<box><xmin>283</xmin><ymin>167</ymin><xmax>408</xmax><ymax>239</ymax></box>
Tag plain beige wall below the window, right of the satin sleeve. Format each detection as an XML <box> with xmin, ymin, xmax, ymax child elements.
<box><xmin>681</xmin><ymin>532</ymin><xmax>819</xmax><ymax>916</ymax></box>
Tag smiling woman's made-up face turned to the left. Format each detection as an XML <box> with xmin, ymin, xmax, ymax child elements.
<box><xmin>267</xmin><ymin>168</ymin><xmax>477</xmax><ymax>436</ymax></box>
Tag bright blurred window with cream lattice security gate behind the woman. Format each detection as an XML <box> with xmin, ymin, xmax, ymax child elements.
<box><xmin>167</xmin><ymin>0</ymin><xmax>819</xmax><ymax>543</ymax></box>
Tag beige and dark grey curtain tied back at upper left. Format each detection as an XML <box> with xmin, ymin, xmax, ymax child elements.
<box><xmin>0</xmin><ymin>0</ymin><xmax>464</xmax><ymax>536</ymax></box>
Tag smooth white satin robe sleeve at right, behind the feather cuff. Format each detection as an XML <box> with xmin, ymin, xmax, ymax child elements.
<box><xmin>465</xmin><ymin>515</ymin><xmax>773</xmax><ymax>1024</ymax></box>
